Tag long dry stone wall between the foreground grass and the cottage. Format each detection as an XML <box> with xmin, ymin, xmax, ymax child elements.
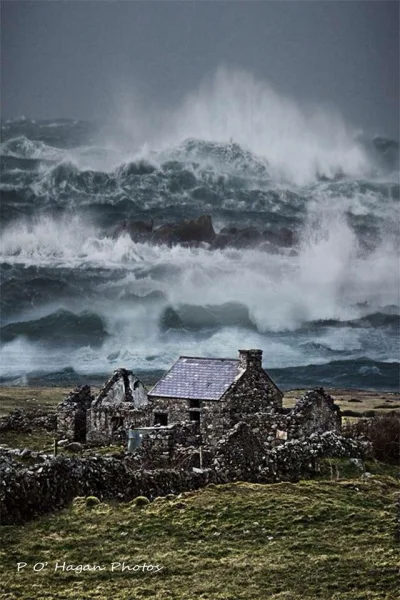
<box><xmin>0</xmin><ymin>423</ymin><xmax>370</xmax><ymax>525</ymax></box>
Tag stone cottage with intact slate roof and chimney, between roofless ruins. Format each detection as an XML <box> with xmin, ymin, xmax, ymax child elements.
<box><xmin>148</xmin><ymin>350</ymin><xmax>283</xmax><ymax>444</ymax></box>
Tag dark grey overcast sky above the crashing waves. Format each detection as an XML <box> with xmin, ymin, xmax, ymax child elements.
<box><xmin>1</xmin><ymin>0</ymin><xmax>399</xmax><ymax>137</ymax></box>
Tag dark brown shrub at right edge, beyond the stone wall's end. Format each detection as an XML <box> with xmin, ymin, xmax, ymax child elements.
<box><xmin>343</xmin><ymin>411</ymin><xmax>400</xmax><ymax>464</ymax></box>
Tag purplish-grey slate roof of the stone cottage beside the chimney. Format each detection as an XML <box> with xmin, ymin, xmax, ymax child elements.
<box><xmin>149</xmin><ymin>356</ymin><xmax>239</xmax><ymax>400</ymax></box>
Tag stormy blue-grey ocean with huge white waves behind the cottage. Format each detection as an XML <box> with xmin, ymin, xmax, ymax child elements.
<box><xmin>0</xmin><ymin>74</ymin><xmax>400</xmax><ymax>390</ymax></box>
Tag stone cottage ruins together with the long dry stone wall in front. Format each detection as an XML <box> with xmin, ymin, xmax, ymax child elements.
<box><xmin>0</xmin><ymin>350</ymin><xmax>370</xmax><ymax>523</ymax></box>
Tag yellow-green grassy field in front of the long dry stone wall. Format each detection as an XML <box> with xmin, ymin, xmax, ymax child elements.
<box><xmin>0</xmin><ymin>475</ymin><xmax>399</xmax><ymax>600</ymax></box>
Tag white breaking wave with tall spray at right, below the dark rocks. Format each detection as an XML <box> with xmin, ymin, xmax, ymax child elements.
<box><xmin>1</xmin><ymin>203</ymin><xmax>399</xmax><ymax>332</ymax></box>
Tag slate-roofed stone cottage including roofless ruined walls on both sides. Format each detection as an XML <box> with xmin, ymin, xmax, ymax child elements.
<box><xmin>58</xmin><ymin>350</ymin><xmax>341</xmax><ymax>458</ymax></box>
